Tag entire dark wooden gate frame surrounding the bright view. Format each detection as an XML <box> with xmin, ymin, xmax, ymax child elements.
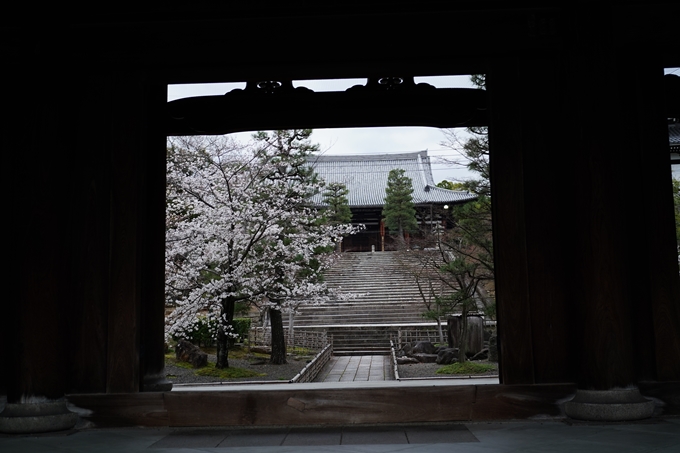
<box><xmin>5</xmin><ymin>4</ymin><xmax>680</xmax><ymax>424</ymax></box>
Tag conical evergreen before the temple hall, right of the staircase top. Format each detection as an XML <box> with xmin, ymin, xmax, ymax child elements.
<box><xmin>382</xmin><ymin>169</ymin><xmax>418</xmax><ymax>244</ymax></box>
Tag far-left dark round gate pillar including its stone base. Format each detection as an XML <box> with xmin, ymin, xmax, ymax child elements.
<box><xmin>0</xmin><ymin>72</ymin><xmax>78</xmax><ymax>433</ymax></box>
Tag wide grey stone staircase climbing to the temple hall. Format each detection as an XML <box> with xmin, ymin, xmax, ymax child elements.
<box><xmin>284</xmin><ymin>252</ymin><xmax>448</xmax><ymax>355</ymax></box>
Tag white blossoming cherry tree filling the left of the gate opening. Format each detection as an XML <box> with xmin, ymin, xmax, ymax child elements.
<box><xmin>166</xmin><ymin>130</ymin><xmax>356</xmax><ymax>368</ymax></box>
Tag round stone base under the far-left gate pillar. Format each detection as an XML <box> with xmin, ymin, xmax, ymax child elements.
<box><xmin>0</xmin><ymin>400</ymin><xmax>78</xmax><ymax>434</ymax></box>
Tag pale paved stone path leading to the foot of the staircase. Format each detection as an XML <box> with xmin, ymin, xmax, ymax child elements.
<box><xmin>314</xmin><ymin>355</ymin><xmax>394</xmax><ymax>382</ymax></box>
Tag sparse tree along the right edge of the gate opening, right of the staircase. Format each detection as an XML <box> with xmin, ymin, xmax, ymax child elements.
<box><xmin>394</xmin><ymin>76</ymin><xmax>495</xmax><ymax>361</ymax></box>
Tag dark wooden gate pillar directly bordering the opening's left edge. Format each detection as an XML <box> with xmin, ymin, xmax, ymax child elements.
<box><xmin>106</xmin><ymin>73</ymin><xmax>172</xmax><ymax>393</ymax></box>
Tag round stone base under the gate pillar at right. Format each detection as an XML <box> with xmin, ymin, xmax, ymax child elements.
<box><xmin>564</xmin><ymin>388</ymin><xmax>654</xmax><ymax>422</ymax></box>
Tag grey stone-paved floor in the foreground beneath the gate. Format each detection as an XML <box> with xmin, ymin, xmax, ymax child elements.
<box><xmin>0</xmin><ymin>418</ymin><xmax>680</xmax><ymax>453</ymax></box>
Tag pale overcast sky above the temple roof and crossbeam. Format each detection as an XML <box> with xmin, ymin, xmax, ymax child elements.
<box><xmin>168</xmin><ymin>76</ymin><xmax>473</xmax><ymax>182</ymax></box>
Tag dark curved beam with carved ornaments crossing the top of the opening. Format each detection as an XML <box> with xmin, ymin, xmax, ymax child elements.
<box><xmin>170</xmin><ymin>75</ymin><xmax>488</xmax><ymax>136</ymax></box>
